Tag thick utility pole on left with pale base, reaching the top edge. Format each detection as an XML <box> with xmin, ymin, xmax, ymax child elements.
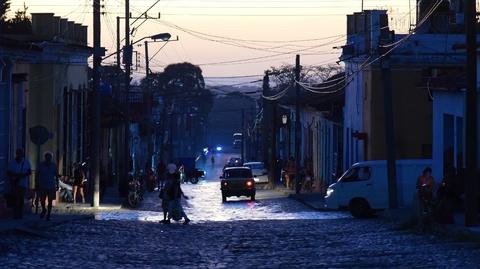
<box><xmin>91</xmin><ymin>0</ymin><xmax>102</xmax><ymax>207</ymax></box>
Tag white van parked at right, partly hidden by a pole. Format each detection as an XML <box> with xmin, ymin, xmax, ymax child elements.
<box><xmin>325</xmin><ymin>160</ymin><xmax>432</xmax><ymax>217</ymax></box>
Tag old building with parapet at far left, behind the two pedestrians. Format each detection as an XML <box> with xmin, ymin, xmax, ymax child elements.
<box><xmin>0</xmin><ymin>13</ymin><xmax>91</xmax><ymax>189</ymax></box>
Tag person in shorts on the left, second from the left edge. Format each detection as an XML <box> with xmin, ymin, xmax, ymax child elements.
<box><xmin>37</xmin><ymin>152</ymin><xmax>58</xmax><ymax>221</ymax></box>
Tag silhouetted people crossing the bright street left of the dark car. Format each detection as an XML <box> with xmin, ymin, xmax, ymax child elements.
<box><xmin>158</xmin><ymin>163</ymin><xmax>190</xmax><ymax>224</ymax></box>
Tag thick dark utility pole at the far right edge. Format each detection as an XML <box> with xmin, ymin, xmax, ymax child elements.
<box><xmin>465</xmin><ymin>0</ymin><xmax>478</xmax><ymax>227</ymax></box>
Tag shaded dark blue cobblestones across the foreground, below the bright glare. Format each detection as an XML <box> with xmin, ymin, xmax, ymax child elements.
<box><xmin>0</xmin><ymin>214</ymin><xmax>480</xmax><ymax>268</ymax></box>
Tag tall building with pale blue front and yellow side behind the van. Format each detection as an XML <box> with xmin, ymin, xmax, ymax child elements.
<box><xmin>341</xmin><ymin>1</ymin><xmax>465</xmax><ymax>170</ymax></box>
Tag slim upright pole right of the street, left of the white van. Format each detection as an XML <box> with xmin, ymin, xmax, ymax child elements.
<box><xmin>295</xmin><ymin>54</ymin><xmax>302</xmax><ymax>193</ymax></box>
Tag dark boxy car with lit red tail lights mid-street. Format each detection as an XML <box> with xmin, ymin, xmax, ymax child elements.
<box><xmin>220</xmin><ymin>167</ymin><xmax>256</xmax><ymax>203</ymax></box>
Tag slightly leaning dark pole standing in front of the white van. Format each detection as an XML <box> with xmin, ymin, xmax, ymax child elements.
<box><xmin>381</xmin><ymin>50</ymin><xmax>398</xmax><ymax>208</ymax></box>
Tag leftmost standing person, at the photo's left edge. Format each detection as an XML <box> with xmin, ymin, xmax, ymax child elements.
<box><xmin>7</xmin><ymin>149</ymin><xmax>32</xmax><ymax>219</ymax></box>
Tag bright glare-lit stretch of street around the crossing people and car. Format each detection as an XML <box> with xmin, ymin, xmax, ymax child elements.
<box><xmin>96</xmin><ymin>154</ymin><xmax>351</xmax><ymax>222</ymax></box>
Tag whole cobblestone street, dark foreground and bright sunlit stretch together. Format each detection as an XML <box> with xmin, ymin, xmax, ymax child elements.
<box><xmin>0</xmin><ymin>152</ymin><xmax>480</xmax><ymax>268</ymax></box>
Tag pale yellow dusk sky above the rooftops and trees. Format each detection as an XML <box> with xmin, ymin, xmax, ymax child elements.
<box><xmin>7</xmin><ymin>0</ymin><xmax>415</xmax><ymax>84</ymax></box>
